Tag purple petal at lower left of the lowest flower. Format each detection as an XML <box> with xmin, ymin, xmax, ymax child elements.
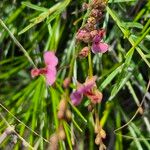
<box><xmin>70</xmin><ymin>91</ymin><xmax>83</xmax><ymax>105</ymax></box>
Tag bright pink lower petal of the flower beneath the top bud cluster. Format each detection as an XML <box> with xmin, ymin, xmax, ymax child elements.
<box><xmin>92</xmin><ymin>42</ymin><xmax>109</xmax><ymax>53</ymax></box>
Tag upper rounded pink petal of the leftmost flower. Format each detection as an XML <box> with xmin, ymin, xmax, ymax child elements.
<box><xmin>44</xmin><ymin>51</ymin><xmax>58</xmax><ymax>67</ymax></box>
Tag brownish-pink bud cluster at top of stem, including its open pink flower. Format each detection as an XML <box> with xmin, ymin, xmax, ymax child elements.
<box><xmin>76</xmin><ymin>0</ymin><xmax>109</xmax><ymax>57</ymax></box>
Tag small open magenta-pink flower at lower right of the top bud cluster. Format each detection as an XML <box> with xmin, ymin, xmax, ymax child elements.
<box><xmin>92</xmin><ymin>35</ymin><xmax>109</xmax><ymax>54</ymax></box>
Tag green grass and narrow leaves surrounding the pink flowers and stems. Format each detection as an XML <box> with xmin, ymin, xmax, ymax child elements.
<box><xmin>0</xmin><ymin>0</ymin><xmax>150</xmax><ymax>150</ymax></box>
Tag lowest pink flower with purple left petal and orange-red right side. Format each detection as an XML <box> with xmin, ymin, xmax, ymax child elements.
<box><xmin>70</xmin><ymin>76</ymin><xmax>102</xmax><ymax>105</ymax></box>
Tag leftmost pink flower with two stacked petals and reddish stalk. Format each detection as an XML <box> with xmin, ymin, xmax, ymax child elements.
<box><xmin>31</xmin><ymin>51</ymin><xmax>58</xmax><ymax>85</ymax></box>
